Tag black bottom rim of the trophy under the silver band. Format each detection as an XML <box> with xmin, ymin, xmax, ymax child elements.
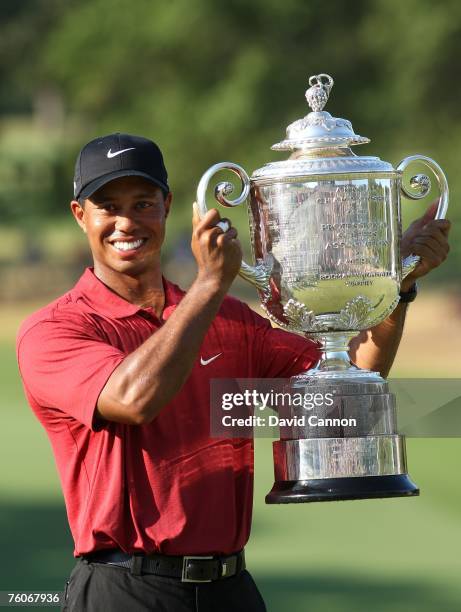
<box><xmin>266</xmin><ymin>474</ymin><xmax>419</xmax><ymax>504</ymax></box>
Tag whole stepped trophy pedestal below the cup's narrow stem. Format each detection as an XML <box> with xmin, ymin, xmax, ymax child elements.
<box><xmin>266</xmin><ymin>366</ymin><xmax>419</xmax><ymax>504</ymax></box>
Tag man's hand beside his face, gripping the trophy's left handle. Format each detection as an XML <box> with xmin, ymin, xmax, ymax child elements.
<box><xmin>191</xmin><ymin>203</ymin><xmax>242</xmax><ymax>291</ymax></box>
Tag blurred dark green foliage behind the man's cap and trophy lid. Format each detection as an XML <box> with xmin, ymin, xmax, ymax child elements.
<box><xmin>0</xmin><ymin>0</ymin><xmax>461</xmax><ymax>280</ymax></box>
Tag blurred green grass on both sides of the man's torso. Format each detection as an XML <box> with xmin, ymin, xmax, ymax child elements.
<box><xmin>0</xmin><ymin>343</ymin><xmax>461</xmax><ymax>612</ymax></box>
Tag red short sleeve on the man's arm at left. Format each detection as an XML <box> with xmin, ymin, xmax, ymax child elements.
<box><xmin>17</xmin><ymin>318</ymin><xmax>126</xmax><ymax>431</ymax></box>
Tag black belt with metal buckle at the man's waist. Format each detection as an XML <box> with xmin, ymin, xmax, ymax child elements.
<box><xmin>83</xmin><ymin>549</ymin><xmax>246</xmax><ymax>582</ymax></box>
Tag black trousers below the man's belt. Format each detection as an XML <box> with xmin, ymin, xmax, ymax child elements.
<box><xmin>61</xmin><ymin>559</ymin><xmax>266</xmax><ymax>612</ymax></box>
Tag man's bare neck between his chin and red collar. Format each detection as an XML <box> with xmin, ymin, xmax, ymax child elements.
<box><xmin>94</xmin><ymin>262</ymin><xmax>165</xmax><ymax>318</ymax></box>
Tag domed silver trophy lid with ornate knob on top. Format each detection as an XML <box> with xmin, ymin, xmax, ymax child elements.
<box><xmin>271</xmin><ymin>74</ymin><xmax>370</xmax><ymax>151</ymax></box>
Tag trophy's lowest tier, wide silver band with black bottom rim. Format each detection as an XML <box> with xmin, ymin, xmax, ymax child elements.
<box><xmin>266</xmin><ymin>435</ymin><xmax>419</xmax><ymax>504</ymax></box>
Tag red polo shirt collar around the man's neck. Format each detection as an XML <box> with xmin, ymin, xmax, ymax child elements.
<box><xmin>72</xmin><ymin>267</ymin><xmax>185</xmax><ymax>319</ymax></box>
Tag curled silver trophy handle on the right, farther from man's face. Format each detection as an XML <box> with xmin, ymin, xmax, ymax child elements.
<box><xmin>397</xmin><ymin>155</ymin><xmax>449</xmax><ymax>279</ymax></box>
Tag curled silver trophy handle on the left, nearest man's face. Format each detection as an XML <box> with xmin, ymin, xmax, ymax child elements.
<box><xmin>197</xmin><ymin>162</ymin><xmax>270</xmax><ymax>293</ymax></box>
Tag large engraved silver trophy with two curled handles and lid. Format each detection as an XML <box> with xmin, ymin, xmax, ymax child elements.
<box><xmin>197</xmin><ymin>74</ymin><xmax>448</xmax><ymax>503</ymax></box>
